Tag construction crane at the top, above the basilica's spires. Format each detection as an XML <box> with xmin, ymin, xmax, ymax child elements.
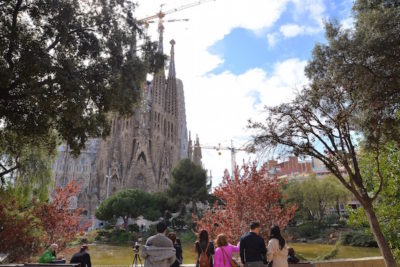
<box><xmin>139</xmin><ymin>0</ymin><xmax>216</xmax><ymax>49</ymax></box>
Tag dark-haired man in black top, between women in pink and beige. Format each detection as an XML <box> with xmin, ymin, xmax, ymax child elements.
<box><xmin>240</xmin><ymin>222</ymin><xmax>267</xmax><ymax>267</ymax></box>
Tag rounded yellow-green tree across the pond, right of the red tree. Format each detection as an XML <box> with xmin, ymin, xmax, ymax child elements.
<box><xmin>284</xmin><ymin>176</ymin><xmax>349</xmax><ymax>223</ymax></box>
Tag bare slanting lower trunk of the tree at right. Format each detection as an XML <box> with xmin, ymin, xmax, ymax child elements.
<box><xmin>364</xmin><ymin>204</ymin><xmax>397</xmax><ymax>267</ymax></box>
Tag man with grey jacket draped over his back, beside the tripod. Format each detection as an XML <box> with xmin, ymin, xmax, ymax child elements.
<box><xmin>142</xmin><ymin>221</ymin><xmax>176</xmax><ymax>267</ymax></box>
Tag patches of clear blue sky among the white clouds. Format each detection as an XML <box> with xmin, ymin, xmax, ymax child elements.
<box><xmin>209</xmin><ymin>0</ymin><xmax>352</xmax><ymax>75</ymax></box>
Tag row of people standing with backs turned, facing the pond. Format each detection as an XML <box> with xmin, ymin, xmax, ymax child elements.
<box><xmin>142</xmin><ymin>222</ymin><xmax>299</xmax><ymax>267</ymax></box>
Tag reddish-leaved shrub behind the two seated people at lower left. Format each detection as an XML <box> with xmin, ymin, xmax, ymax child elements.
<box><xmin>35</xmin><ymin>180</ymin><xmax>88</xmax><ymax>247</ymax></box>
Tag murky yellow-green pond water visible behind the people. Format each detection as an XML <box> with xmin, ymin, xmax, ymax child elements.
<box><xmin>65</xmin><ymin>243</ymin><xmax>380</xmax><ymax>265</ymax></box>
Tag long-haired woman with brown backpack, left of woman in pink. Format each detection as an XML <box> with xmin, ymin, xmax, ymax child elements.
<box><xmin>195</xmin><ymin>230</ymin><xmax>215</xmax><ymax>267</ymax></box>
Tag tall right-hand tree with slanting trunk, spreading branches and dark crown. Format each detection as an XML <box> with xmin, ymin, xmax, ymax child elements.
<box><xmin>250</xmin><ymin>0</ymin><xmax>400</xmax><ymax>266</ymax></box>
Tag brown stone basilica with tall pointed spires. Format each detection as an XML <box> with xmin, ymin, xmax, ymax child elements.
<box><xmin>52</xmin><ymin>29</ymin><xmax>202</xmax><ymax>217</ymax></box>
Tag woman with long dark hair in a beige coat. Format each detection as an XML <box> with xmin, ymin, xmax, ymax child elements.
<box><xmin>267</xmin><ymin>225</ymin><xmax>289</xmax><ymax>267</ymax></box>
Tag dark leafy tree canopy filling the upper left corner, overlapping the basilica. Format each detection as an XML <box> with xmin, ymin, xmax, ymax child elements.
<box><xmin>0</xmin><ymin>0</ymin><xmax>164</xmax><ymax>182</ymax></box>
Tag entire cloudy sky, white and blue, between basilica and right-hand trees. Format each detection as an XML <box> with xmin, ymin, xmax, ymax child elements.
<box><xmin>136</xmin><ymin>0</ymin><xmax>353</xmax><ymax>186</ymax></box>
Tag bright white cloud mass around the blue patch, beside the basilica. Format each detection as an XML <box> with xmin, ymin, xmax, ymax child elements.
<box><xmin>137</xmin><ymin>0</ymin><xmax>310</xmax><ymax>186</ymax></box>
